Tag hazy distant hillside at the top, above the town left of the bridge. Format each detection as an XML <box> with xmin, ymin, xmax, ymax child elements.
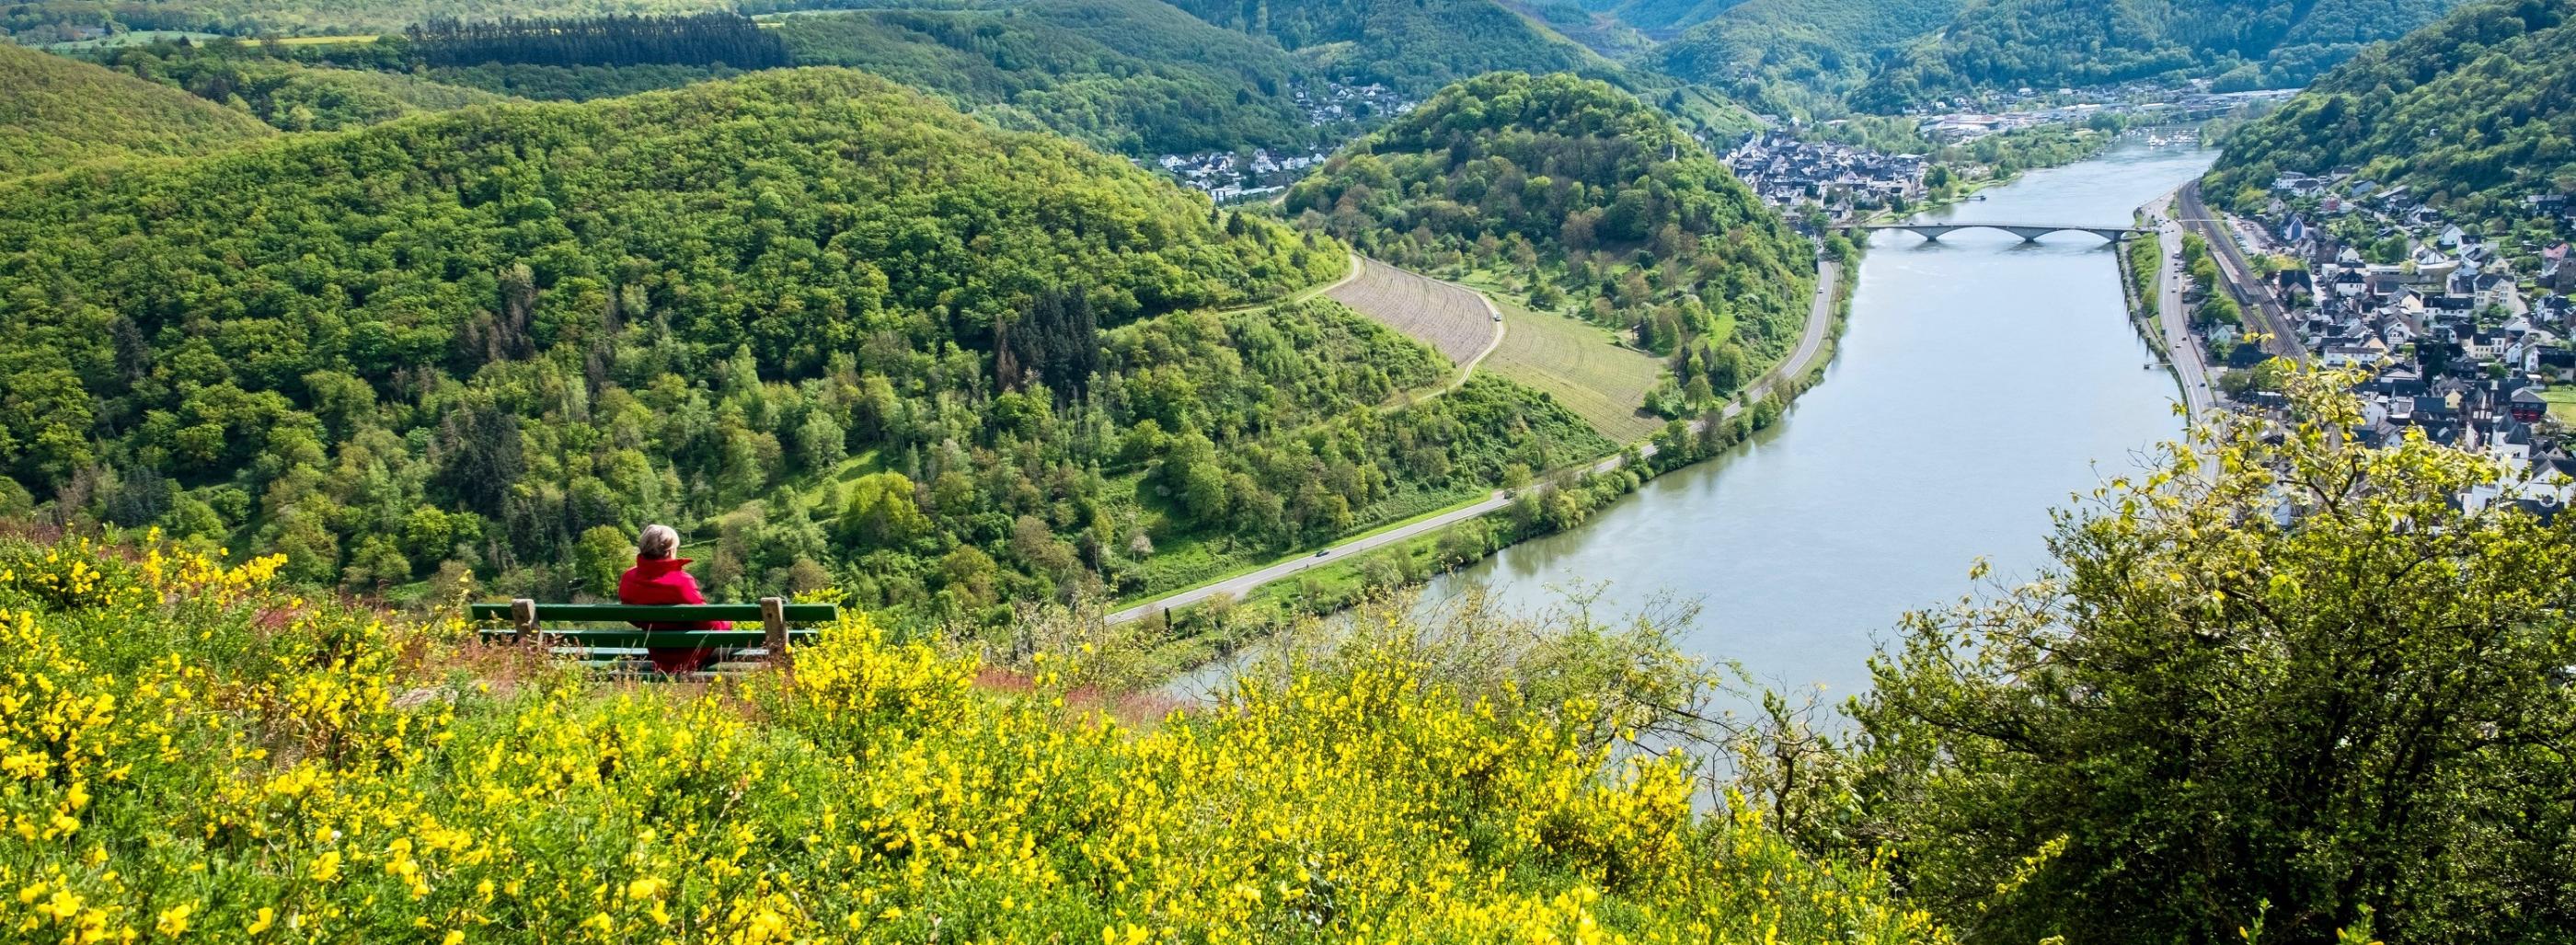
<box><xmin>1643</xmin><ymin>0</ymin><xmax>1963</xmax><ymax>113</ymax></box>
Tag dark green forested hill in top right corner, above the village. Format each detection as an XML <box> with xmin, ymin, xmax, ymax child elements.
<box><xmin>2205</xmin><ymin>0</ymin><xmax>2576</xmax><ymax>219</ymax></box>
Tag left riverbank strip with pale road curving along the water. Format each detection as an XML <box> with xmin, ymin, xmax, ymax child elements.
<box><xmin>1105</xmin><ymin>255</ymin><xmax>1857</xmax><ymax>677</ymax></box>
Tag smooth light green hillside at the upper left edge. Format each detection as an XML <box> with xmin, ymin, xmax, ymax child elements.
<box><xmin>0</xmin><ymin>44</ymin><xmax>273</xmax><ymax>178</ymax></box>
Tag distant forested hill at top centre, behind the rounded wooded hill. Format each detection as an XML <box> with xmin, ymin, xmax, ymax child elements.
<box><xmin>1178</xmin><ymin>0</ymin><xmax>1617</xmax><ymax>93</ymax></box>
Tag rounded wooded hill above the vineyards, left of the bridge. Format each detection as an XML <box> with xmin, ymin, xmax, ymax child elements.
<box><xmin>1285</xmin><ymin>72</ymin><xmax>1813</xmax><ymax>415</ymax></box>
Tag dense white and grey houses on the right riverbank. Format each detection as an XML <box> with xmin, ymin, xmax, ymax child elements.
<box><xmin>2210</xmin><ymin>170</ymin><xmax>2576</xmax><ymax>515</ymax></box>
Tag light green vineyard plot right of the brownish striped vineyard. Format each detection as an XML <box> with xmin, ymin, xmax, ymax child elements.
<box><xmin>1484</xmin><ymin>301</ymin><xmax>1664</xmax><ymax>443</ymax></box>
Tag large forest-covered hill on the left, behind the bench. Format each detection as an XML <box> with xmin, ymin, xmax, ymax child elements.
<box><xmin>0</xmin><ymin>70</ymin><xmax>1607</xmax><ymax>626</ymax></box>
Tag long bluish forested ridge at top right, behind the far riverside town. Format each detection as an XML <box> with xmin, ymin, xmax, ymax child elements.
<box><xmin>1852</xmin><ymin>0</ymin><xmax>2455</xmax><ymax>110</ymax></box>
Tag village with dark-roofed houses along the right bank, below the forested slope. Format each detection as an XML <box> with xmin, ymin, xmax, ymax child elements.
<box><xmin>2169</xmin><ymin>167</ymin><xmax>2576</xmax><ymax>517</ymax></box>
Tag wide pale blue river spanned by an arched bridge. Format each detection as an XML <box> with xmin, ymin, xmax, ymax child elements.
<box><xmin>1424</xmin><ymin>142</ymin><xmax>2215</xmax><ymax>703</ymax></box>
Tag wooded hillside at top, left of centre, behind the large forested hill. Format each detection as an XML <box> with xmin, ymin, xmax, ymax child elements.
<box><xmin>778</xmin><ymin>0</ymin><xmax>1321</xmax><ymax>155</ymax></box>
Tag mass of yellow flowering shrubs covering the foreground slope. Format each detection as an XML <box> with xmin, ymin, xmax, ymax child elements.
<box><xmin>0</xmin><ymin>541</ymin><xmax>1948</xmax><ymax>945</ymax></box>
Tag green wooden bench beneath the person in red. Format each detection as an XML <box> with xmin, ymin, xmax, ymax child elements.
<box><xmin>466</xmin><ymin>597</ymin><xmax>840</xmax><ymax>672</ymax></box>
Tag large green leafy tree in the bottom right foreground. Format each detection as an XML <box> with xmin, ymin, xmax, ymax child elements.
<box><xmin>1845</xmin><ymin>374</ymin><xmax>2576</xmax><ymax>942</ymax></box>
